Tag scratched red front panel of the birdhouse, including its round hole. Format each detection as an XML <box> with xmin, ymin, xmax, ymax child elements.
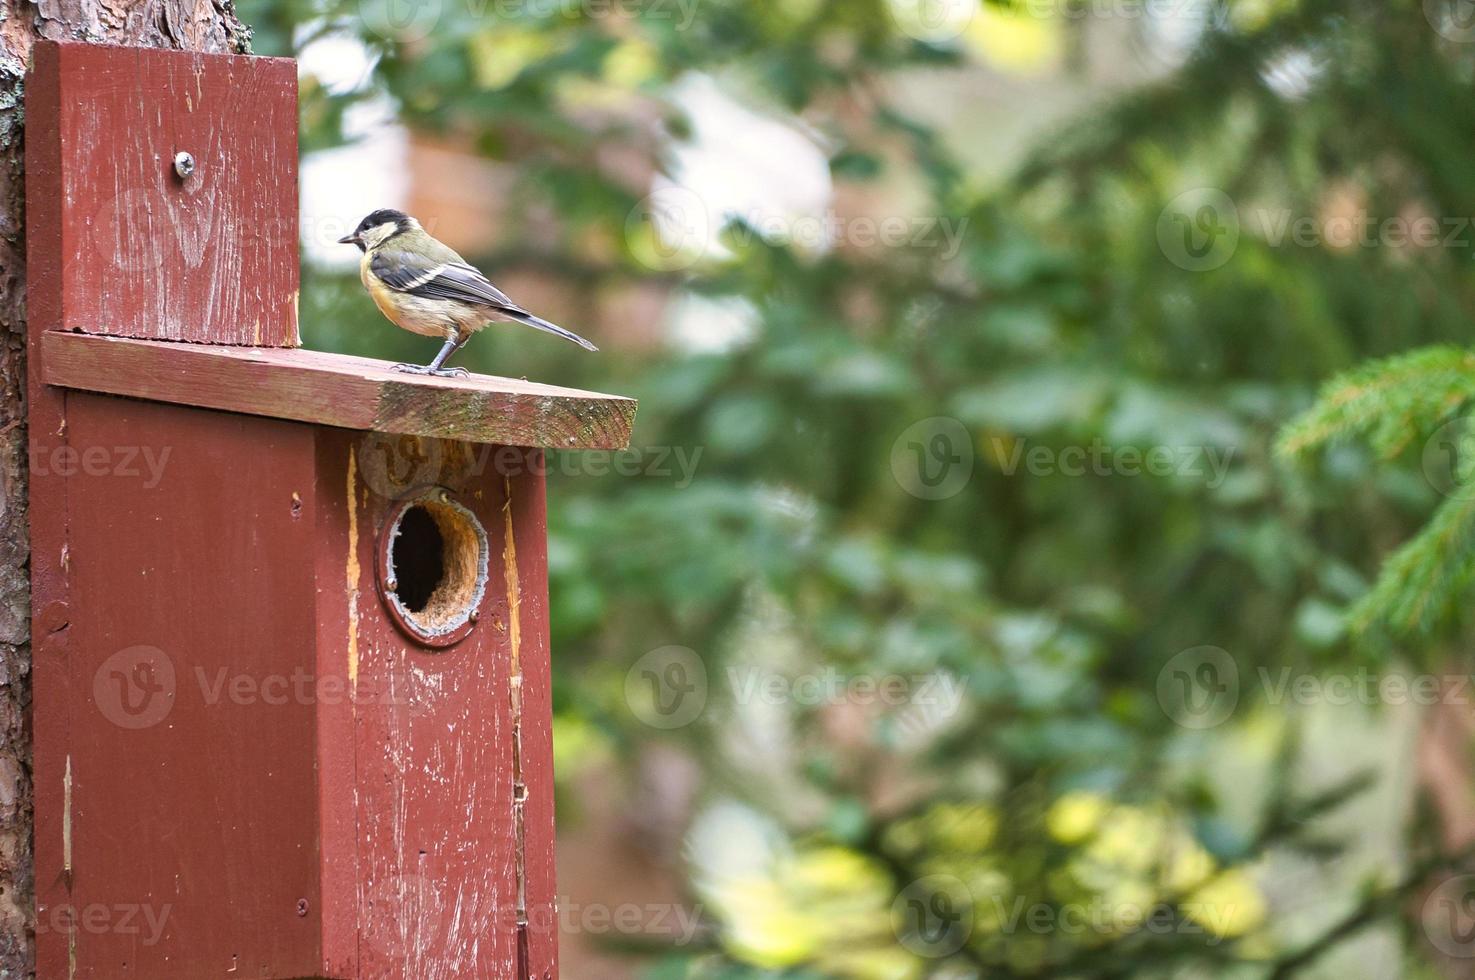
<box><xmin>317</xmin><ymin>429</ymin><xmax>556</xmax><ymax>979</ymax></box>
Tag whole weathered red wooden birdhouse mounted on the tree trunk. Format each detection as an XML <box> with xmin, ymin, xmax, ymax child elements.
<box><xmin>27</xmin><ymin>43</ymin><xmax>634</xmax><ymax>980</ymax></box>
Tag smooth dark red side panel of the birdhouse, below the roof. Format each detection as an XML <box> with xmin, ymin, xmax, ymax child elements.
<box><xmin>61</xmin><ymin>394</ymin><xmax>324</xmax><ymax>980</ymax></box>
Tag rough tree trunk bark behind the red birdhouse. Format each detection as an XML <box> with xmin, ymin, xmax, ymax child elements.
<box><xmin>0</xmin><ymin>0</ymin><xmax>251</xmax><ymax>980</ymax></box>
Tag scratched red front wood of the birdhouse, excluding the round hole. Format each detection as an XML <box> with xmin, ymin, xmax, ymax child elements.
<box><xmin>314</xmin><ymin>429</ymin><xmax>558</xmax><ymax>980</ymax></box>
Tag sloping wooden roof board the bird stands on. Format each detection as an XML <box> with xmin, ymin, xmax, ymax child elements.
<box><xmin>41</xmin><ymin>332</ymin><xmax>636</xmax><ymax>449</ymax></box>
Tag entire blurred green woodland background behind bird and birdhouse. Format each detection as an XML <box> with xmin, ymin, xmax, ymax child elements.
<box><xmin>230</xmin><ymin>0</ymin><xmax>1475</xmax><ymax>980</ymax></box>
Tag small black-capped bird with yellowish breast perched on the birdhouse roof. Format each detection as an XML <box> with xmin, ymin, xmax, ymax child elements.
<box><xmin>338</xmin><ymin>208</ymin><xmax>599</xmax><ymax>378</ymax></box>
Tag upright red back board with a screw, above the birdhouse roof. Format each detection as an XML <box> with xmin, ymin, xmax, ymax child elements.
<box><xmin>41</xmin><ymin>41</ymin><xmax>299</xmax><ymax>347</ymax></box>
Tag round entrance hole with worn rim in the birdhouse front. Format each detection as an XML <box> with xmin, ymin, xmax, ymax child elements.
<box><xmin>379</xmin><ymin>490</ymin><xmax>488</xmax><ymax>646</ymax></box>
